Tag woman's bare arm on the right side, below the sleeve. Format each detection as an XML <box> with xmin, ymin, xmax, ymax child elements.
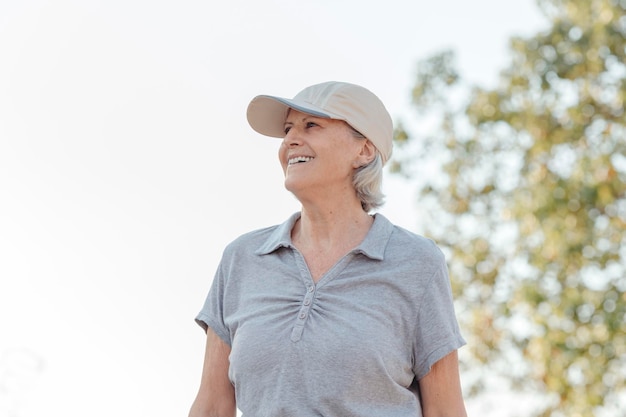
<box><xmin>419</xmin><ymin>350</ymin><xmax>467</xmax><ymax>417</ymax></box>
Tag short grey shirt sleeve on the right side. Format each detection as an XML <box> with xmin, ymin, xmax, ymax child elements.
<box><xmin>413</xmin><ymin>260</ymin><xmax>465</xmax><ymax>380</ymax></box>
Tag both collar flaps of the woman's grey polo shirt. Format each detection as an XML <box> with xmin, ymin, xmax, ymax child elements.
<box><xmin>255</xmin><ymin>212</ymin><xmax>394</xmax><ymax>261</ymax></box>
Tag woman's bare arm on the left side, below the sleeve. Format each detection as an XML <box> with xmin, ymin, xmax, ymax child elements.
<box><xmin>189</xmin><ymin>327</ymin><xmax>237</xmax><ymax>417</ymax></box>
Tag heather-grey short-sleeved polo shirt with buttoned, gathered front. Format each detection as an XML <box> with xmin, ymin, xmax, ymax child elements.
<box><xmin>196</xmin><ymin>213</ymin><xmax>465</xmax><ymax>417</ymax></box>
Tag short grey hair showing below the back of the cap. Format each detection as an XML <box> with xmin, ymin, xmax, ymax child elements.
<box><xmin>348</xmin><ymin>125</ymin><xmax>385</xmax><ymax>213</ymax></box>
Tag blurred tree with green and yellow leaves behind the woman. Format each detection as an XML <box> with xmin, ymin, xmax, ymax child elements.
<box><xmin>392</xmin><ymin>0</ymin><xmax>626</xmax><ymax>417</ymax></box>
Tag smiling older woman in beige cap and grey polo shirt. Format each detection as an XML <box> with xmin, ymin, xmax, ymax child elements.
<box><xmin>189</xmin><ymin>82</ymin><xmax>466</xmax><ymax>417</ymax></box>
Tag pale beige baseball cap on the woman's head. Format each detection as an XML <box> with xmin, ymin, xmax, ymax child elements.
<box><xmin>247</xmin><ymin>81</ymin><xmax>393</xmax><ymax>163</ymax></box>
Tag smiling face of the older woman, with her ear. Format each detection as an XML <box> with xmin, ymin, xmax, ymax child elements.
<box><xmin>279</xmin><ymin>110</ymin><xmax>374</xmax><ymax>198</ymax></box>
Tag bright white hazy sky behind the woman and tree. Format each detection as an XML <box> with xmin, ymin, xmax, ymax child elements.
<box><xmin>0</xmin><ymin>0</ymin><xmax>545</xmax><ymax>417</ymax></box>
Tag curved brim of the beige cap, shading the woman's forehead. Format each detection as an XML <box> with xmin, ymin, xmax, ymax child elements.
<box><xmin>247</xmin><ymin>96</ymin><xmax>332</xmax><ymax>138</ymax></box>
